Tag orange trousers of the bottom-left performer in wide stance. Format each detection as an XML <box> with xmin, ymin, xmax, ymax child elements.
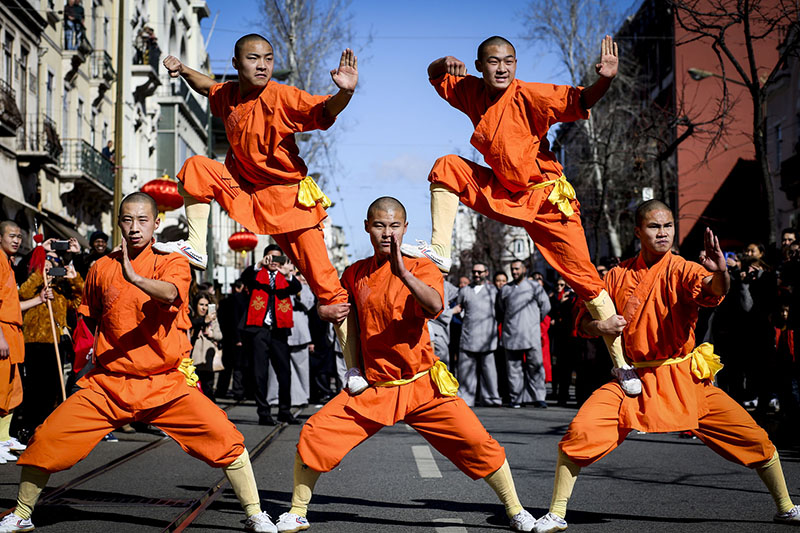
<box><xmin>17</xmin><ymin>380</ymin><xmax>245</xmax><ymax>473</ymax></box>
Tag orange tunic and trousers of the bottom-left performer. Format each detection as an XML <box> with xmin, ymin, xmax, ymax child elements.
<box><xmin>18</xmin><ymin>246</ymin><xmax>244</xmax><ymax>473</ymax></box>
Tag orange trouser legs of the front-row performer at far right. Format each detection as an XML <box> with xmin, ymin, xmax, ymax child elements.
<box><xmin>558</xmin><ymin>382</ymin><xmax>775</xmax><ymax>468</ymax></box>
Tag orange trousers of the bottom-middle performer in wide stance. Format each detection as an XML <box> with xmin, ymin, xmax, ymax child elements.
<box><xmin>297</xmin><ymin>378</ymin><xmax>506</xmax><ymax>479</ymax></box>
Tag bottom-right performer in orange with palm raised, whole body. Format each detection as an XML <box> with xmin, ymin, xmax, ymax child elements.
<box><xmin>534</xmin><ymin>200</ymin><xmax>800</xmax><ymax>533</ymax></box>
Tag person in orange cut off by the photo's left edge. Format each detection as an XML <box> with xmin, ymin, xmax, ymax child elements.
<box><xmin>0</xmin><ymin>220</ymin><xmax>53</xmax><ymax>464</ymax></box>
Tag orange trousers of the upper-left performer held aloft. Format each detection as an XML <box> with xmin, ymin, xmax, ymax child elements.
<box><xmin>178</xmin><ymin>156</ymin><xmax>348</xmax><ymax>305</ymax></box>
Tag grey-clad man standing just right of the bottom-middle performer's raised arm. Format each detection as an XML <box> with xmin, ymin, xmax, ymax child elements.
<box><xmin>458</xmin><ymin>263</ymin><xmax>502</xmax><ymax>407</ymax></box>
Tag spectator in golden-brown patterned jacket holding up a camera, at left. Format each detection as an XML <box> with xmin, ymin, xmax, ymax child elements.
<box><xmin>19</xmin><ymin>238</ymin><xmax>83</xmax><ymax>440</ymax></box>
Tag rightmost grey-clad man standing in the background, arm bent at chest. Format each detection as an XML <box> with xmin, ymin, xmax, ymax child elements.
<box><xmin>496</xmin><ymin>261</ymin><xmax>550</xmax><ymax>408</ymax></box>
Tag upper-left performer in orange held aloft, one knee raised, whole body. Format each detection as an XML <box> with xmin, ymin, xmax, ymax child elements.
<box><xmin>155</xmin><ymin>34</ymin><xmax>358</xmax><ymax>376</ymax></box>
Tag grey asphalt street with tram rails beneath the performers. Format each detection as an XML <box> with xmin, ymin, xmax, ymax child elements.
<box><xmin>0</xmin><ymin>404</ymin><xmax>800</xmax><ymax>533</ymax></box>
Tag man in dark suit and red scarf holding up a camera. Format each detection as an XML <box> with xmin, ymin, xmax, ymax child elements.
<box><xmin>241</xmin><ymin>244</ymin><xmax>302</xmax><ymax>426</ymax></box>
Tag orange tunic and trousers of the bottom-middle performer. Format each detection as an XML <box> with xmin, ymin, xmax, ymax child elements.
<box><xmin>297</xmin><ymin>256</ymin><xmax>505</xmax><ymax>479</ymax></box>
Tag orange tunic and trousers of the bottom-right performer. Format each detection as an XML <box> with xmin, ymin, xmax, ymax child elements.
<box><xmin>559</xmin><ymin>253</ymin><xmax>775</xmax><ymax>467</ymax></box>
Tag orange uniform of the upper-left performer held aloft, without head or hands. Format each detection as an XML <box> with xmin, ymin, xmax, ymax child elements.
<box><xmin>178</xmin><ymin>81</ymin><xmax>347</xmax><ymax>305</ymax></box>
